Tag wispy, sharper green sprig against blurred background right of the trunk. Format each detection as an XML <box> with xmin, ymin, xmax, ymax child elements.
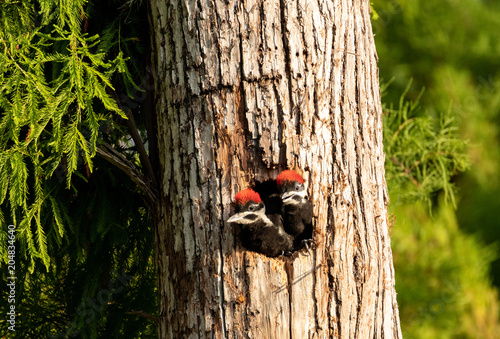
<box><xmin>383</xmin><ymin>82</ymin><xmax>469</xmax><ymax>207</ymax></box>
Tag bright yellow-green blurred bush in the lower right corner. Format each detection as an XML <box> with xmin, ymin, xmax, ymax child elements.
<box><xmin>392</xmin><ymin>204</ymin><xmax>500</xmax><ymax>339</ymax></box>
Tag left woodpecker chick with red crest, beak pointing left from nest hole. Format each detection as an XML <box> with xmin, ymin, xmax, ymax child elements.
<box><xmin>227</xmin><ymin>189</ymin><xmax>294</xmax><ymax>257</ymax></box>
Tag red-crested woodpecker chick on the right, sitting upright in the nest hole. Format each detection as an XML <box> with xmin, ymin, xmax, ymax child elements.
<box><xmin>276</xmin><ymin>170</ymin><xmax>313</xmax><ymax>250</ymax></box>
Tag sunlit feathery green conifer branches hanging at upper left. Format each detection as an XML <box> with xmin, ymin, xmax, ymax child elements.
<box><xmin>0</xmin><ymin>1</ymin><xmax>133</xmax><ymax>268</ymax></box>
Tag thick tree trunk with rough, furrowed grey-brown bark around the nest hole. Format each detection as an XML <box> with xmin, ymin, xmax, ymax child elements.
<box><xmin>150</xmin><ymin>0</ymin><xmax>401</xmax><ymax>338</ymax></box>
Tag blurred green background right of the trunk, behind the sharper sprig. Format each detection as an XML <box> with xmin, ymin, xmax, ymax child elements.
<box><xmin>372</xmin><ymin>0</ymin><xmax>500</xmax><ymax>338</ymax></box>
